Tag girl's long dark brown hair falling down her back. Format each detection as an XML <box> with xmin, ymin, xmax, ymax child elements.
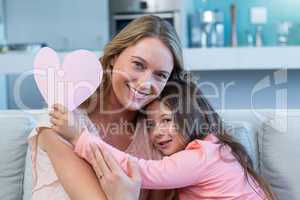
<box><xmin>159</xmin><ymin>75</ymin><xmax>276</xmax><ymax>200</ymax></box>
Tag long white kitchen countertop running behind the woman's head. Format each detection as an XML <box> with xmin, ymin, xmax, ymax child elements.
<box><xmin>0</xmin><ymin>46</ymin><xmax>300</xmax><ymax>74</ymax></box>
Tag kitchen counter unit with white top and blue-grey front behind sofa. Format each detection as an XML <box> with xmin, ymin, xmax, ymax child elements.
<box><xmin>0</xmin><ymin>47</ymin><xmax>300</xmax><ymax>109</ymax></box>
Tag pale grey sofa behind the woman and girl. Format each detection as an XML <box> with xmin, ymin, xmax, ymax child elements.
<box><xmin>0</xmin><ymin>110</ymin><xmax>300</xmax><ymax>200</ymax></box>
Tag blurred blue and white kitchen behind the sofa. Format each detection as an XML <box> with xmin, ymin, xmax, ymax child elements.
<box><xmin>0</xmin><ymin>0</ymin><xmax>300</xmax><ymax>109</ymax></box>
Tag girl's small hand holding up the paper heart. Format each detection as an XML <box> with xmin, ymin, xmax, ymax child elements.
<box><xmin>49</xmin><ymin>104</ymin><xmax>83</xmax><ymax>145</ymax></box>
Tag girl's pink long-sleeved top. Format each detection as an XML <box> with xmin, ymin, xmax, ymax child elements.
<box><xmin>74</xmin><ymin>130</ymin><xmax>266</xmax><ymax>200</ymax></box>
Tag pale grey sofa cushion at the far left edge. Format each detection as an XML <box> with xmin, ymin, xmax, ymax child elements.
<box><xmin>0</xmin><ymin>111</ymin><xmax>32</xmax><ymax>200</ymax></box>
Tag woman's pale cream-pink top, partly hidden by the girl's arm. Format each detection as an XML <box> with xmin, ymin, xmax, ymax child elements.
<box><xmin>28</xmin><ymin>109</ymin><xmax>161</xmax><ymax>200</ymax></box>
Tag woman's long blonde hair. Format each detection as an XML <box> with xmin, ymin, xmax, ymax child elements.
<box><xmin>80</xmin><ymin>15</ymin><xmax>183</xmax><ymax>111</ymax></box>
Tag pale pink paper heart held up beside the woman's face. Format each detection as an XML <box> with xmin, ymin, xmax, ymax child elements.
<box><xmin>34</xmin><ymin>47</ymin><xmax>103</xmax><ymax>111</ymax></box>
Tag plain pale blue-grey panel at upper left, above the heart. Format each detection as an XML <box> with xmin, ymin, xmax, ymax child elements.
<box><xmin>5</xmin><ymin>0</ymin><xmax>109</xmax><ymax>50</ymax></box>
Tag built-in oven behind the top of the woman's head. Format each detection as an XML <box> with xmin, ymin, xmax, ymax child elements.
<box><xmin>109</xmin><ymin>0</ymin><xmax>187</xmax><ymax>45</ymax></box>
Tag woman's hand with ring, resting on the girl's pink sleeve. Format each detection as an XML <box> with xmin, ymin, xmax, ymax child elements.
<box><xmin>91</xmin><ymin>144</ymin><xmax>141</xmax><ymax>200</ymax></box>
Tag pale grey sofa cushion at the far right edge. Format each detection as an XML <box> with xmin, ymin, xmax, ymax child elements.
<box><xmin>258</xmin><ymin>112</ymin><xmax>300</xmax><ymax>200</ymax></box>
